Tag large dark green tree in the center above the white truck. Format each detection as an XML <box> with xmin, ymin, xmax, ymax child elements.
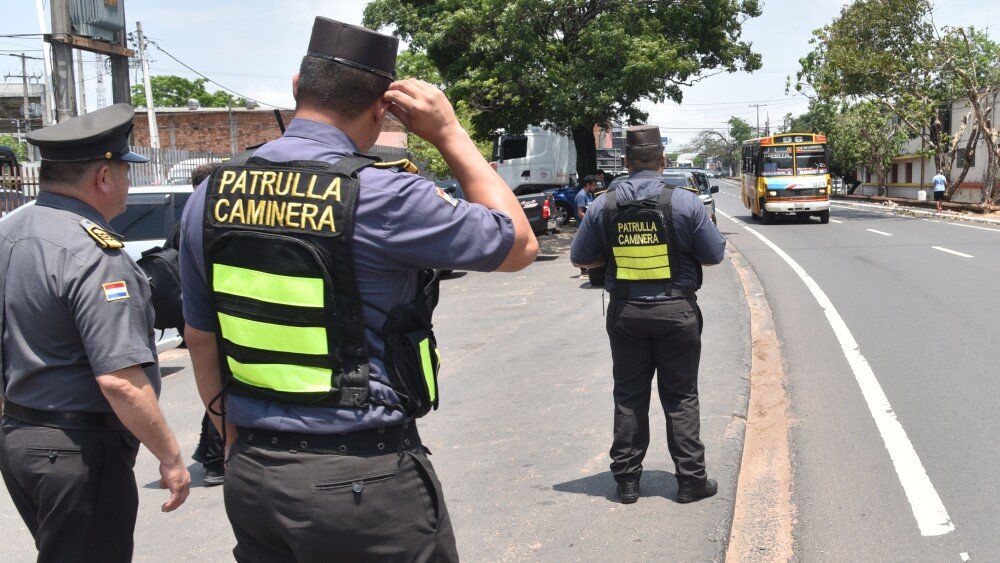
<box><xmin>364</xmin><ymin>0</ymin><xmax>760</xmax><ymax>183</ymax></box>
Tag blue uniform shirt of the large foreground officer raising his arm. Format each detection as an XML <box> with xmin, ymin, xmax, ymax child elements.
<box><xmin>181</xmin><ymin>118</ymin><xmax>514</xmax><ymax>434</ymax></box>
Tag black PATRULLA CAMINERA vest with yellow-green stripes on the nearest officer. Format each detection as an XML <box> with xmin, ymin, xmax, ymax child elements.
<box><xmin>204</xmin><ymin>155</ymin><xmax>439</xmax><ymax>416</ymax></box>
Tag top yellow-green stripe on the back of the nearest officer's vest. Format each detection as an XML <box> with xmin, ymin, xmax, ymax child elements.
<box><xmin>212</xmin><ymin>264</ymin><xmax>323</xmax><ymax>307</ymax></box>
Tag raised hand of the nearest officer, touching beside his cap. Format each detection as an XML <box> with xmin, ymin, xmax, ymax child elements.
<box><xmin>383</xmin><ymin>78</ymin><xmax>462</xmax><ymax>150</ymax></box>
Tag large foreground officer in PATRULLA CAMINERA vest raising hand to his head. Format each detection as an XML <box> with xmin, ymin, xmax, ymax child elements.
<box><xmin>181</xmin><ymin>17</ymin><xmax>538</xmax><ymax>561</ymax></box>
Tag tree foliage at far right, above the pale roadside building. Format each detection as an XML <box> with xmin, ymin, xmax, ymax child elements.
<box><xmin>789</xmin><ymin>0</ymin><xmax>1000</xmax><ymax>203</ymax></box>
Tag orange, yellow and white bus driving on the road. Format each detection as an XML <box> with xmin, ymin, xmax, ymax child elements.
<box><xmin>741</xmin><ymin>133</ymin><xmax>831</xmax><ymax>224</ymax></box>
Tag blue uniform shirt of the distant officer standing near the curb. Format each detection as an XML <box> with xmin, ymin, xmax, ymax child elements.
<box><xmin>570</xmin><ymin>170</ymin><xmax>726</xmax><ymax>290</ymax></box>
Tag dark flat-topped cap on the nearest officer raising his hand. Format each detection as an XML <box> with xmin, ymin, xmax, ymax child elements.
<box><xmin>306</xmin><ymin>16</ymin><xmax>399</xmax><ymax>80</ymax></box>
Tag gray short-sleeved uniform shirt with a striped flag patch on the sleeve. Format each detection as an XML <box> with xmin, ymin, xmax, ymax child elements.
<box><xmin>0</xmin><ymin>192</ymin><xmax>160</xmax><ymax>412</ymax></box>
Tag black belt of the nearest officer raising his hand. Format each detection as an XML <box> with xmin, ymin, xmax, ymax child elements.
<box><xmin>237</xmin><ymin>422</ymin><xmax>421</xmax><ymax>455</ymax></box>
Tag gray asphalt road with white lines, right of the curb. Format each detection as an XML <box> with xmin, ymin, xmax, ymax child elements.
<box><xmin>717</xmin><ymin>182</ymin><xmax>1000</xmax><ymax>561</ymax></box>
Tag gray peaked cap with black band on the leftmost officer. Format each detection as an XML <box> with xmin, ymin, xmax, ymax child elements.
<box><xmin>27</xmin><ymin>104</ymin><xmax>149</xmax><ymax>162</ymax></box>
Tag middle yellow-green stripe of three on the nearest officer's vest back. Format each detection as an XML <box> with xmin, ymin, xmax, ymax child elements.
<box><xmin>219</xmin><ymin>313</ymin><xmax>328</xmax><ymax>355</ymax></box>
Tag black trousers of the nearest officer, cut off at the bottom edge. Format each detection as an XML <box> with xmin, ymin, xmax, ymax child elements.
<box><xmin>223</xmin><ymin>440</ymin><xmax>458</xmax><ymax>563</ymax></box>
